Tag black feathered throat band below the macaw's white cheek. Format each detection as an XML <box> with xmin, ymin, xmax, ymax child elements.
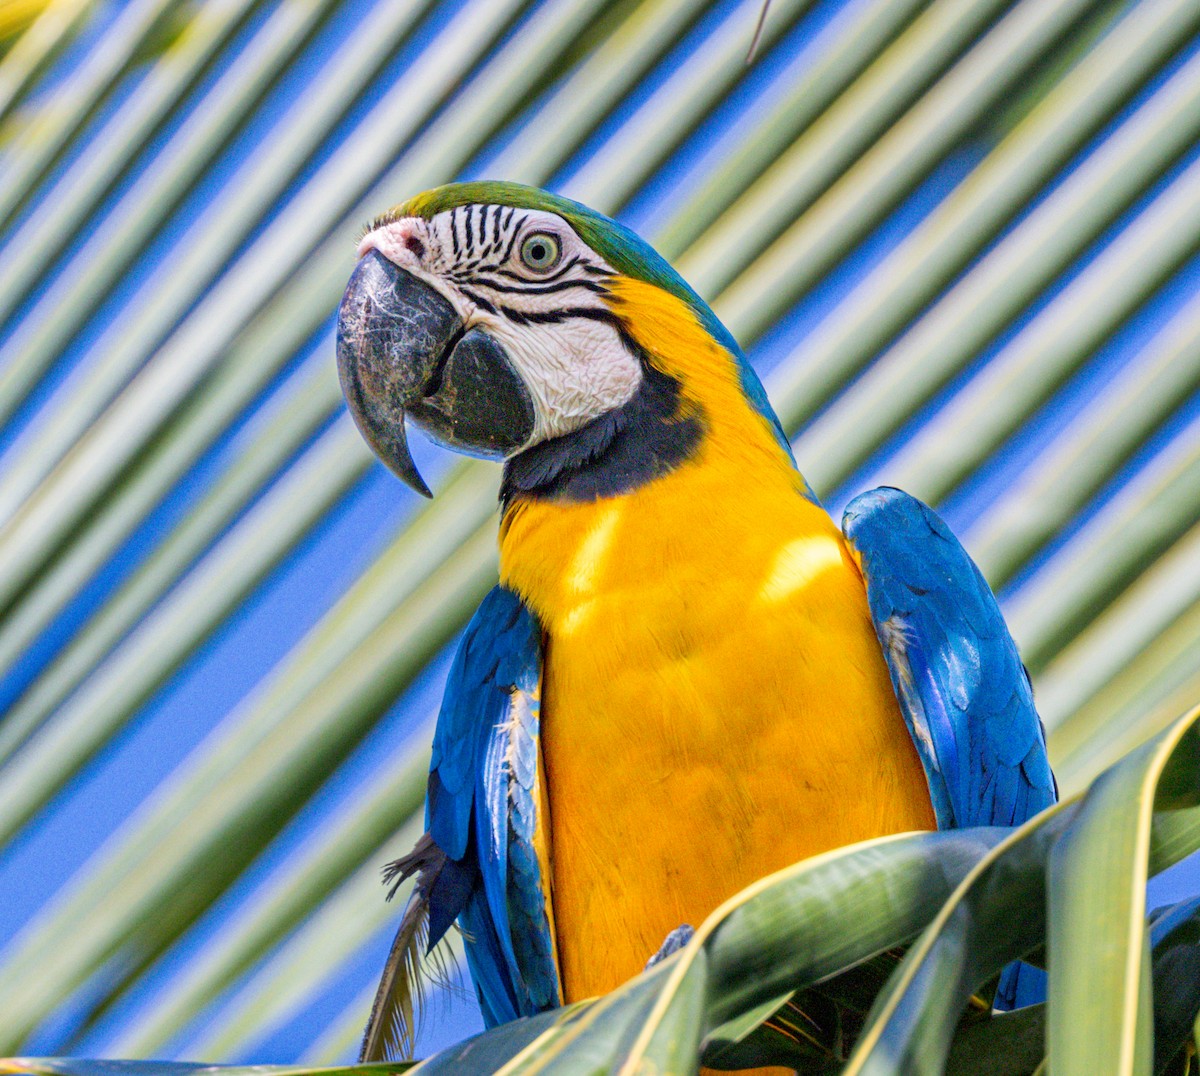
<box><xmin>500</xmin><ymin>359</ymin><xmax>704</xmax><ymax>505</ymax></box>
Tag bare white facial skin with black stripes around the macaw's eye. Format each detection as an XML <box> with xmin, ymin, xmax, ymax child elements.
<box><xmin>359</xmin><ymin>205</ymin><xmax>642</xmax><ymax>451</ymax></box>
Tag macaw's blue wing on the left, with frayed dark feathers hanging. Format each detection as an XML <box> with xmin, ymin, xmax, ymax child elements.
<box><xmin>361</xmin><ymin>587</ymin><xmax>560</xmax><ymax>1060</ymax></box>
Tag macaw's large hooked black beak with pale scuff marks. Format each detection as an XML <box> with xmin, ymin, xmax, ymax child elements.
<box><xmin>337</xmin><ymin>251</ymin><xmax>535</xmax><ymax>497</ymax></box>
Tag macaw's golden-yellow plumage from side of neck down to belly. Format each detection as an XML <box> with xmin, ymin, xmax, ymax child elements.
<box><xmin>500</xmin><ymin>281</ymin><xmax>934</xmax><ymax>999</ymax></box>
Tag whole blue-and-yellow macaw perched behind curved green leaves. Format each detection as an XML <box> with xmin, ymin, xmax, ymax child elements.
<box><xmin>337</xmin><ymin>182</ymin><xmax>1055</xmax><ymax>1058</ymax></box>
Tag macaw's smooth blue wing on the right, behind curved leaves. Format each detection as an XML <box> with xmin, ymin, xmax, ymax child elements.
<box><xmin>841</xmin><ymin>488</ymin><xmax>1057</xmax><ymax>1009</ymax></box>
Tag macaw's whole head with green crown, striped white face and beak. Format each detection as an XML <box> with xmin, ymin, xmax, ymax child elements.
<box><xmin>337</xmin><ymin>182</ymin><xmax>790</xmax><ymax>495</ymax></box>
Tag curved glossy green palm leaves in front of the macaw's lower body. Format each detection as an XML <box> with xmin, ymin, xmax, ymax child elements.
<box><xmin>10</xmin><ymin>707</ymin><xmax>1200</xmax><ymax>1076</ymax></box>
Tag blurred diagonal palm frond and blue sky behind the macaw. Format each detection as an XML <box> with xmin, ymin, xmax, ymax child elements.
<box><xmin>0</xmin><ymin>0</ymin><xmax>1200</xmax><ymax>1062</ymax></box>
